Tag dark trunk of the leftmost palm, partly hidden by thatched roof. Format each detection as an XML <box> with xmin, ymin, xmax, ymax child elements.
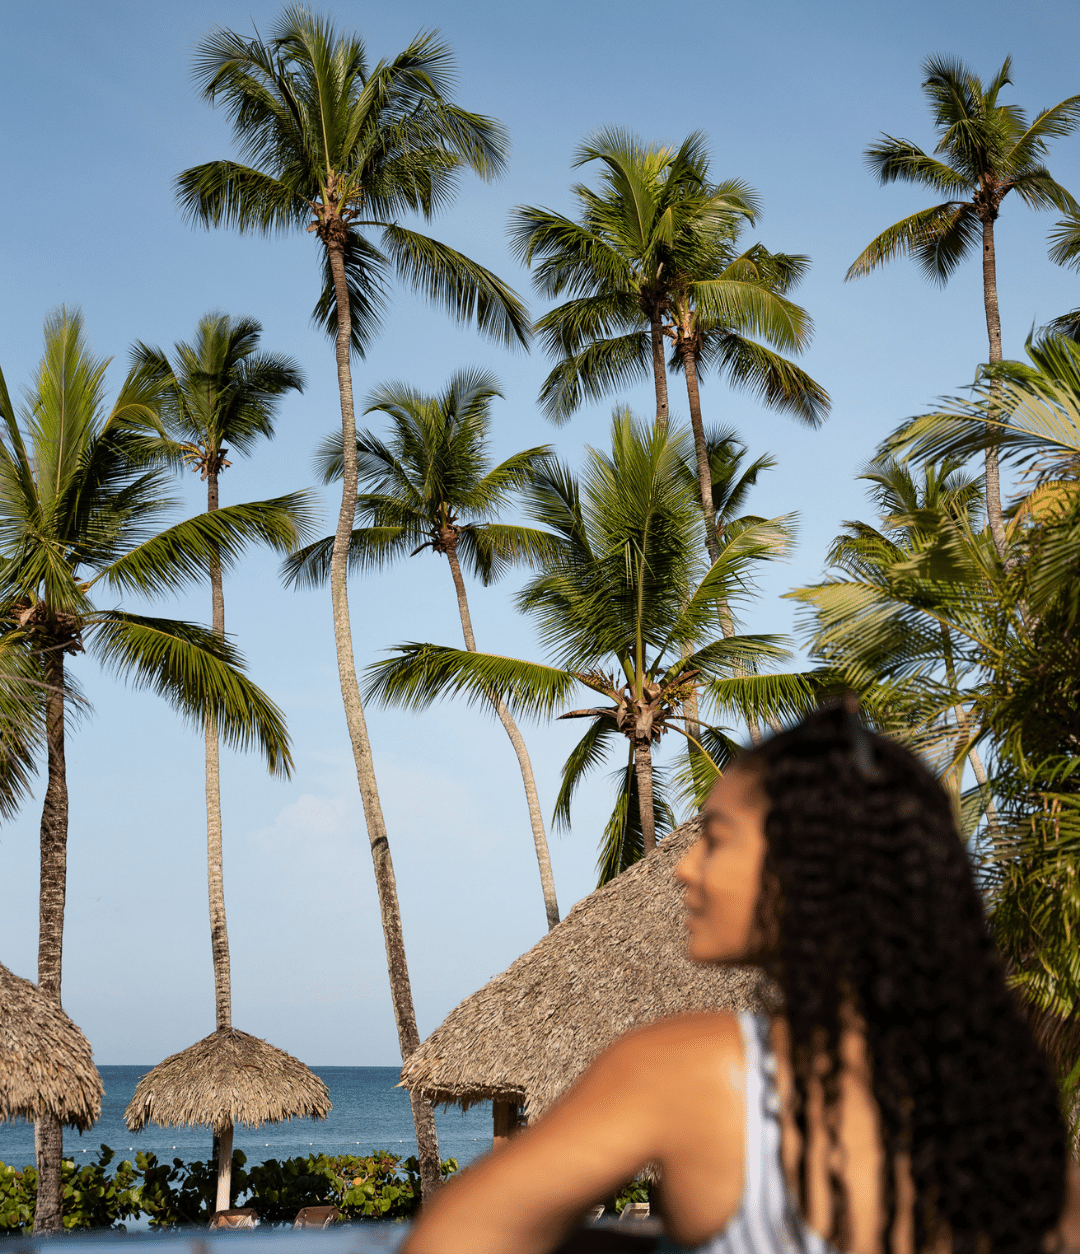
<box><xmin>34</xmin><ymin>641</ymin><xmax>68</xmax><ymax>1234</ymax></box>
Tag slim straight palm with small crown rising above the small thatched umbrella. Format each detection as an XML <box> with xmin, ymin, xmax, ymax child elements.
<box><xmin>133</xmin><ymin>314</ymin><xmax>304</xmax><ymax>1038</ymax></box>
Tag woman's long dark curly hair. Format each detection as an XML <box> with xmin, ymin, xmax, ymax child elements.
<box><xmin>741</xmin><ymin>706</ymin><xmax>1066</xmax><ymax>1254</ymax></box>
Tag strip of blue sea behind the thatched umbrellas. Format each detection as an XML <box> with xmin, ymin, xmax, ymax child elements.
<box><xmin>0</xmin><ymin>1067</ymin><xmax>492</xmax><ymax>1167</ymax></box>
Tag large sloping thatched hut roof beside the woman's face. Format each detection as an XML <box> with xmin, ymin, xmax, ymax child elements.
<box><xmin>401</xmin><ymin>819</ymin><xmax>766</xmax><ymax>1116</ymax></box>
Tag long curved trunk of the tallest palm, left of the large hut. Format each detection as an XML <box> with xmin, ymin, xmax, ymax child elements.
<box><xmin>326</xmin><ymin>223</ymin><xmax>443</xmax><ymax>1198</ymax></box>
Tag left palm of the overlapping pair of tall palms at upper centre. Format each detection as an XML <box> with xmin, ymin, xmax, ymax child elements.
<box><xmin>512</xmin><ymin>129</ymin><xmax>757</xmax><ymax>428</ymax></box>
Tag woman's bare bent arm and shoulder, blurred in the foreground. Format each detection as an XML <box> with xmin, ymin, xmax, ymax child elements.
<box><xmin>401</xmin><ymin>1014</ymin><xmax>743</xmax><ymax>1254</ymax></box>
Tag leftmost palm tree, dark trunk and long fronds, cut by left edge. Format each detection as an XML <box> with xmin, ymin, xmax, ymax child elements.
<box><xmin>0</xmin><ymin>311</ymin><xmax>304</xmax><ymax>1231</ymax></box>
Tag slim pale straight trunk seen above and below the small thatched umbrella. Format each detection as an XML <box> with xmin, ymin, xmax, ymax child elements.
<box><xmin>206</xmin><ymin>471</ymin><xmax>232</xmax><ymax>1210</ymax></box>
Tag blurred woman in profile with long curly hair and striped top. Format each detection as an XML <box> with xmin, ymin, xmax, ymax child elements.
<box><xmin>403</xmin><ymin>709</ymin><xmax>1080</xmax><ymax>1254</ymax></box>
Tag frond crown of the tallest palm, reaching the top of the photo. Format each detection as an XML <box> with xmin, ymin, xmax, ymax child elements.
<box><xmin>177</xmin><ymin>6</ymin><xmax>528</xmax><ymax>355</ymax></box>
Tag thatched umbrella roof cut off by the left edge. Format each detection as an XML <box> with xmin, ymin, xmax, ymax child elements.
<box><xmin>0</xmin><ymin>966</ymin><xmax>104</xmax><ymax>1131</ymax></box>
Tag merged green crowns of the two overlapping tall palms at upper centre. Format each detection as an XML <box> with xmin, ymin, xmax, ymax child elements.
<box><xmin>512</xmin><ymin>130</ymin><xmax>828</xmax><ymax>424</ymax></box>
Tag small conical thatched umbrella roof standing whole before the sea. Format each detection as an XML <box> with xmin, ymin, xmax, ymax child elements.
<box><xmin>124</xmin><ymin>1028</ymin><xmax>330</xmax><ymax>1132</ymax></box>
